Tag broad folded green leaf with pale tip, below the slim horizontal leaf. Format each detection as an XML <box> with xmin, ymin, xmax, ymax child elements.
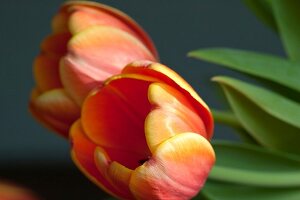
<box><xmin>213</xmin><ymin>77</ymin><xmax>300</xmax><ymax>153</ymax></box>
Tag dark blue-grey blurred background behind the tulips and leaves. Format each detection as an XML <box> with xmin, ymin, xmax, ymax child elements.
<box><xmin>0</xmin><ymin>0</ymin><xmax>283</xmax><ymax>200</ymax></box>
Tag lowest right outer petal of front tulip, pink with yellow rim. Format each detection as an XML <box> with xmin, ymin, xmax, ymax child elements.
<box><xmin>129</xmin><ymin>133</ymin><xmax>215</xmax><ymax>200</ymax></box>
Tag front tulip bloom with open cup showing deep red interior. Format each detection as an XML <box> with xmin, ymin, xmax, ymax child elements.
<box><xmin>70</xmin><ymin>61</ymin><xmax>215</xmax><ymax>200</ymax></box>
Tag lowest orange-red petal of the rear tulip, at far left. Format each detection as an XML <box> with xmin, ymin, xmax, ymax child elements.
<box><xmin>29</xmin><ymin>89</ymin><xmax>80</xmax><ymax>137</ymax></box>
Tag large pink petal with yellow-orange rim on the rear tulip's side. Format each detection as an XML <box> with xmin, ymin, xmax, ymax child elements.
<box><xmin>60</xmin><ymin>26</ymin><xmax>154</xmax><ymax>105</ymax></box>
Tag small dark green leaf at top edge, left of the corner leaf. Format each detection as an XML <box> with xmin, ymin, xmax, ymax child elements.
<box><xmin>244</xmin><ymin>0</ymin><xmax>277</xmax><ymax>32</ymax></box>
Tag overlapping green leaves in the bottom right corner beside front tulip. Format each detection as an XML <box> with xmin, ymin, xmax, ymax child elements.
<box><xmin>195</xmin><ymin>141</ymin><xmax>300</xmax><ymax>200</ymax></box>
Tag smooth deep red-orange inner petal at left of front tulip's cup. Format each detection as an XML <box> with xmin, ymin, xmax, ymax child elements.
<box><xmin>81</xmin><ymin>78</ymin><xmax>151</xmax><ymax>169</ymax></box>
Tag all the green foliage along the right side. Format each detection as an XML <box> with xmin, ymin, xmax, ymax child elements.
<box><xmin>188</xmin><ymin>0</ymin><xmax>300</xmax><ymax>200</ymax></box>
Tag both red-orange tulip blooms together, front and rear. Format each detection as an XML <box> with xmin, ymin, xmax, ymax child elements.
<box><xmin>30</xmin><ymin>2</ymin><xmax>215</xmax><ymax>199</ymax></box>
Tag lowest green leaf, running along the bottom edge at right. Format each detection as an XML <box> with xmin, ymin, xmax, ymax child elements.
<box><xmin>200</xmin><ymin>180</ymin><xmax>300</xmax><ymax>200</ymax></box>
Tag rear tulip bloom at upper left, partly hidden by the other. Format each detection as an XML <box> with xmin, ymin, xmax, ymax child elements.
<box><xmin>29</xmin><ymin>1</ymin><xmax>157</xmax><ymax>137</ymax></box>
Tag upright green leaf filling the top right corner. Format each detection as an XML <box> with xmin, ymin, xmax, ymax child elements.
<box><xmin>270</xmin><ymin>0</ymin><xmax>300</xmax><ymax>61</ymax></box>
